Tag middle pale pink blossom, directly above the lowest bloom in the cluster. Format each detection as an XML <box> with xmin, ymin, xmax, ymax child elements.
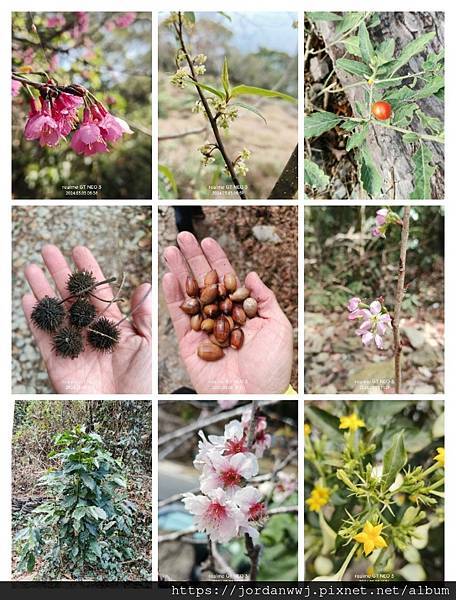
<box><xmin>200</xmin><ymin>452</ymin><xmax>258</xmax><ymax>495</ymax></box>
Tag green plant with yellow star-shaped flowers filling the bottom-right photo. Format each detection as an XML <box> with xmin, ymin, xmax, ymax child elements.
<box><xmin>304</xmin><ymin>400</ymin><xmax>445</xmax><ymax>581</ymax></box>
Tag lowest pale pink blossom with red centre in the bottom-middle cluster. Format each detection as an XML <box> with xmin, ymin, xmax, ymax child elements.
<box><xmin>183</xmin><ymin>488</ymin><xmax>249</xmax><ymax>544</ymax></box>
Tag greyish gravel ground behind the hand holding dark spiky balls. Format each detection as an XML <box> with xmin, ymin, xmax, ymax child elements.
<box><xmin>11</xmin><ymin>206</ymin><xmax>152</xmax><ymax>394</ymax></box>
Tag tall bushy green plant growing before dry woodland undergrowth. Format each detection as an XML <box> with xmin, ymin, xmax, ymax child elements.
<box><xmin>16</xmin><ymin>425</ymin><xmax>136</xmax><ymax>579</ymax></box>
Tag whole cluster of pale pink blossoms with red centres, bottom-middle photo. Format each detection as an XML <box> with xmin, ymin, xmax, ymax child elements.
<box><xmin>183</xmin><ymin>412</ymin><xmax>271</xmax><ymax>543</ymax></box>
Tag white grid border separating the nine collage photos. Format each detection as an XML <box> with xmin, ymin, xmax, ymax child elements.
<box><xmin>0</xmin><ymin>0</ymin><xmax>456</xmax><ymax>581</ymax></box>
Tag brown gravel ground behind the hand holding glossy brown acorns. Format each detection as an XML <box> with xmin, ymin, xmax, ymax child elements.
<box><xmin>158</xmin><ymin>206</ymin><xmax>298</xmax><ymax>394</ymax></box>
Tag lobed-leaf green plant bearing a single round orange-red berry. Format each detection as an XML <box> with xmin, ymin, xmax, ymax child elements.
<box><xmin>304</xmin><ymin>12</ymin><xmax>444</xmax><ymax>199</ymax></box>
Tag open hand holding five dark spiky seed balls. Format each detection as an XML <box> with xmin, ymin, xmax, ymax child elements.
<box><xmin>22</xmin><ymin>245</ymin><xmax>152</xmax><ymax>394</ymax></box>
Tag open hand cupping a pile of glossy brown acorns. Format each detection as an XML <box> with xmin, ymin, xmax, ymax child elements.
<box><xmin>163</xmin><ymin>231</ymin><xmax>293</xmax><ymax>394</ymax></box>
